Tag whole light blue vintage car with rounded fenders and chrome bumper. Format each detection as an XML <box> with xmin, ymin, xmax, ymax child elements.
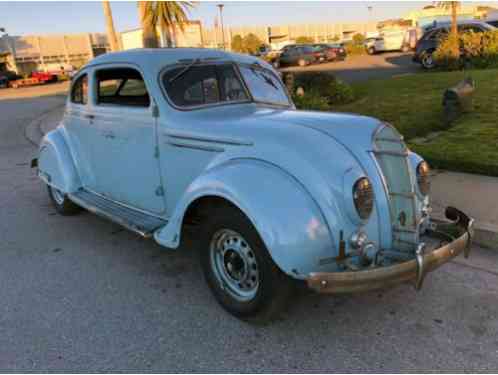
<box><xmin>34</xmin><ymin>49</ymin><xmax>473</xmax><ymax>319</ymax></box>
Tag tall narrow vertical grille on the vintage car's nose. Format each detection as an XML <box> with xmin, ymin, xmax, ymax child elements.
<box><xmin>373</xmin><ymin>125</ymin><xmax>419</xmax><ymax>252</ymax></box>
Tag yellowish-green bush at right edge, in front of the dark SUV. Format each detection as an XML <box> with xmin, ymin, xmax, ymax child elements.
<box><xmin>434</xmin><ymin>31</ymin><xmax>498</xmax><ymax>70</ymax></box>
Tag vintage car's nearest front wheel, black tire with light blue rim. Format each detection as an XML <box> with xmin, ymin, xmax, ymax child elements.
<box><xmin>200</xmin><ymin>206</ymin><xmax>292</xmax><ymax>322</ymax></box>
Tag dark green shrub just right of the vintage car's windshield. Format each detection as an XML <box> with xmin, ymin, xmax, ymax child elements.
<box><xmin>294</xmin><ymin>72</ymin><xmax>354</xmax><ymax>109</ymax></box>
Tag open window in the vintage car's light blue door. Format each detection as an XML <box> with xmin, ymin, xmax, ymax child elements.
<box><xmin>96</xmin><ymin>68</ymin><xmax>150</xmax><ymax>107</ymax></box>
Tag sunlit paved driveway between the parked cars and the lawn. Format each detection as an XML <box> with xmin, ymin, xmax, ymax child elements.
<box><xmin>281</xmin><ymin>52</ymin><xmax>421</xmax><ymax>83</ymax></box>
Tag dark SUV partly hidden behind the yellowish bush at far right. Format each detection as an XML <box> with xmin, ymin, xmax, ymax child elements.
<box><xmin>413</xmin><ymin>21</ymin><xmax>496</xmax><ymax>69</ymax></box>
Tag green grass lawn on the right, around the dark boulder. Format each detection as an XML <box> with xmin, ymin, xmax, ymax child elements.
<box><xmin>333</xmin><ymin>69</ymin><xmax>498</xmax><ymax>176</ymax></box>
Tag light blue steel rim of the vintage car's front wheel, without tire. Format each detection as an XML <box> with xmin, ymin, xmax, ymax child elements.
<box><xmin>209</xmin><ymin>229</ymin><xmax>259</xmax><ymax>302</ymax></box>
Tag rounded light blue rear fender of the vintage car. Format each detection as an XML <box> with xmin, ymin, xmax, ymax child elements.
<box><xmin>38</xmin><ymin>128</ymin><xmax>81</xmax><ymax>193</ymax></box>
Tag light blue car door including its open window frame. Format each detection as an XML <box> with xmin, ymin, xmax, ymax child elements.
<box><xmin>88</xmin><ymin>65</ymin><xmax>166</xmax><ymax>215</ymax></box>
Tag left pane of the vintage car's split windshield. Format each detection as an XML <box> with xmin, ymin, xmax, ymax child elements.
<box><xmin>163</xmin><ymin>64</ymin><xmax>248</xmax><ymax>107</ymax></box>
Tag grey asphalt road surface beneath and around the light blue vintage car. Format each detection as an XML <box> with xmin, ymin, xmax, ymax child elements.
<box><xmin>0</xmin><ymin>83</ymin><xmax>498</xmax><ymax>372</ymax></box>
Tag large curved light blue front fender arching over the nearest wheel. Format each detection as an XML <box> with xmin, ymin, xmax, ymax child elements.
<box><xmin>154</xmin><ymin>158</ymin><xmax>336</xmax><ymax>279</ymax></box>
